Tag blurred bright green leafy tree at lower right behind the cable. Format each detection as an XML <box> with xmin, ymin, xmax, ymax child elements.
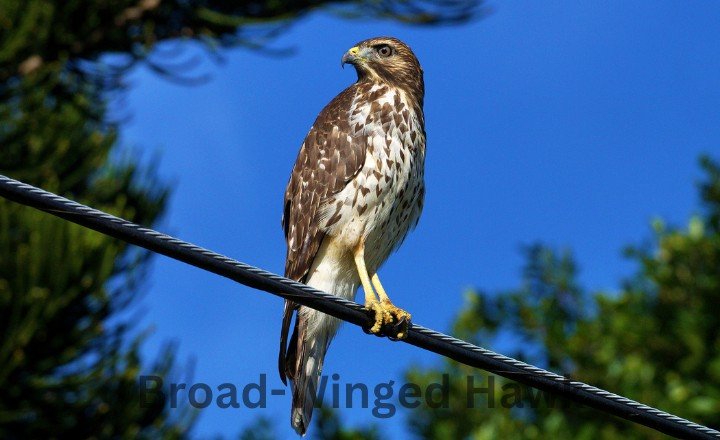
<box><xmin>408</xmin><ymin>158</ymin><xmax>720</xmax><ymax>439</ymax></box>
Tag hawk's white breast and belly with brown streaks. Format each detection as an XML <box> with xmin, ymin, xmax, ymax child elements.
<box><xmin>320</xmin><ymin>84</ymin><xmax>425</xmax><ymax>271</ymax></box>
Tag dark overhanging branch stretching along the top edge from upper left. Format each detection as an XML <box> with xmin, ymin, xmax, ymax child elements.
<box><xmin>0</xmin><ymin>0</ymin><xmax>481</xmax><ymax>85</ymax></box>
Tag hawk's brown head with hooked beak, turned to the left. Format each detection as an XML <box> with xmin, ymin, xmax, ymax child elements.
<box><xmin>342</xmin><ymin>37</ymin><xmax>424</xmax><ymax>98</ymax></box>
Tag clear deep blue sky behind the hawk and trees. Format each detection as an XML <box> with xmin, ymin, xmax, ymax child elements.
<box><xmin>118</xmin><ymin>1</ymin><xmax>720</xmax><ymax>438</ymax></box>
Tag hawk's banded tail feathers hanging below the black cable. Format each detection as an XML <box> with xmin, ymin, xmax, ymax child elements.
<box><xmin>290</xmin><ymin>332</ymin><xmax>330</xmax><ymax>436</ymax></box>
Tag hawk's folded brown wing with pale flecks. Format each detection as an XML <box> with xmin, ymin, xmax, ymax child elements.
<box><xmin>278</xmin><ymin>84</ymin><xmax>367</xmax><ymax>382</ymax></box>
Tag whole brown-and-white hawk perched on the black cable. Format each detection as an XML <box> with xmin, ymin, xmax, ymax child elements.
<box><xmin>279</xmin><ymin>37</ymin><xmax>425</xmax><ymax>435</ymax></box>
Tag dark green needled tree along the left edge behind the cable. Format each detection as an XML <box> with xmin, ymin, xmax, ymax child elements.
<box><xmin>0</xmin><ymin>50</ymin><xmax>190</xmax><ymax>438</ymax></box>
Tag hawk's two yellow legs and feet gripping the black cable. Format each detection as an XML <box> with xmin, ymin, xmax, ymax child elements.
<box><xmin>353</xmin><ymin>243</ymin><xmax>410</xmax><ymax>339</ymax></box>
